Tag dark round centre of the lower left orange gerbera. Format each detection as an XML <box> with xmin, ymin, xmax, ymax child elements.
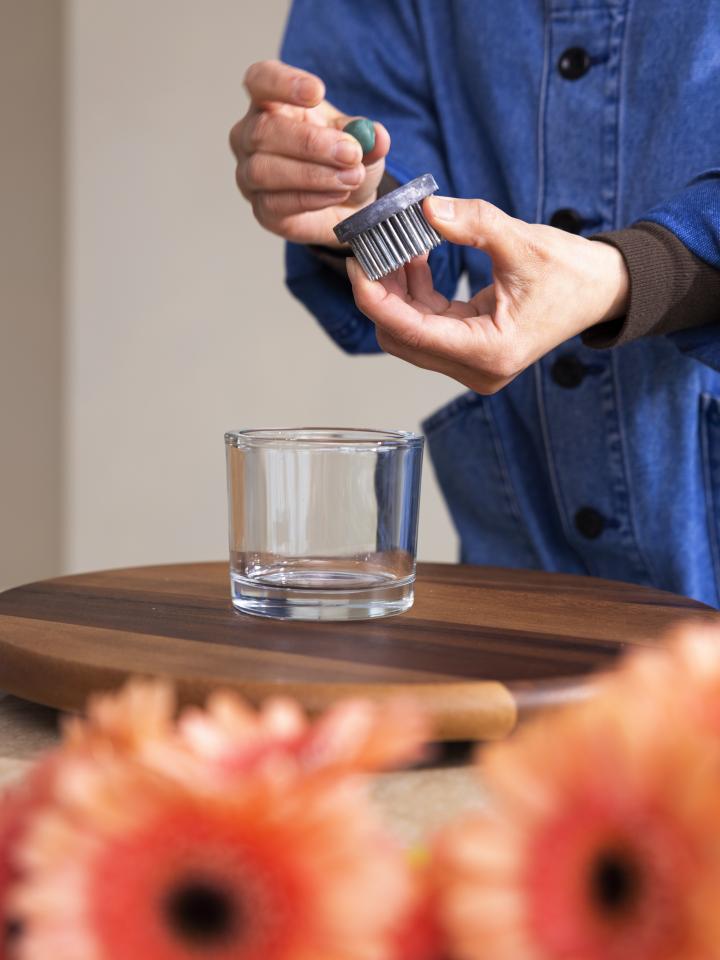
<box><xmin>165</xmin><ymin>879</ymin><xmax>241</xmax><ymax>946</ymax></box>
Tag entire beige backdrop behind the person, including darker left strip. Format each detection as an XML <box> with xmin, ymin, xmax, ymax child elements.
<box><xmin>0</xmin><ymin>0</ymin><xmax>461</xmax><ymax>587</ymax></box>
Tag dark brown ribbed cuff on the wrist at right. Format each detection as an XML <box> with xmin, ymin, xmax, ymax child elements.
<box><xmin>582</xmin><ymin>221</ymin><xmax>720</xmax><ymax>349</ymax></box>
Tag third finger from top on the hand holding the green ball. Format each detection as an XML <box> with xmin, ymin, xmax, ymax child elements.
<box><xmin>237</xmin><ymin>153</ymin><xmax>365</xmax><ymax>196</ymax></box>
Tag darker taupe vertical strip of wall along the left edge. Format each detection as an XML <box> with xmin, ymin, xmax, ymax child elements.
<box><xmin>0</xmin><ymin>0</ymin><xmax>62</xmax><ymax>589</ymax></box>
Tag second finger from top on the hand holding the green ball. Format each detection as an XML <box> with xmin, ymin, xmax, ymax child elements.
<box><xmin>230</xmin><ymin>111</ymin><xmax>362</xmax><ymax>168</ymax></box>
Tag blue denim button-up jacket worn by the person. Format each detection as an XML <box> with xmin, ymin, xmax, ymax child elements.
<box><xmin>282</xmin><ymin>0</ymin><xmax>720</xmax><ymax>606</ymax></box>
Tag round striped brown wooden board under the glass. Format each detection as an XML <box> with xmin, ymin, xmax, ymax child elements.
<box><xmin>0</xmin><ymin>563</ymin><xmax>715</xmax><ymax>740</ymax></box>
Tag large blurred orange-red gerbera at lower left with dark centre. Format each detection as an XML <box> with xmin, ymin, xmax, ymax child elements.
<box><xmin>16</xmin><ymin>759</ymin><xmax>408</xmax><ymax>960</ymax></box>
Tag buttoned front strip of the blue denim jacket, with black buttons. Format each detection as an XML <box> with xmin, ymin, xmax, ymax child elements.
<box><xmin>535</xmin><ymin>0</ymin><xmax>650</xmax><ymax>582</ymax></box>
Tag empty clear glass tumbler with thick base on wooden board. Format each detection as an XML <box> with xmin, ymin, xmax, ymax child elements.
<box><xmin>225</xmin><ymin>428</ymin><xmax>424</xmax><ymax>620</ymax></box>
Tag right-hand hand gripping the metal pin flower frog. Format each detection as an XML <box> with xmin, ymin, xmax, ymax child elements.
<box><xmin>348</xmin><ymin>197</ymin><xmax>629</xmax><ymax>394</ymax></box>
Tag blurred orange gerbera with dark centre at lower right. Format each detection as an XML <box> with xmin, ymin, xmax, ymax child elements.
<box><xmin>437</xmin><ymin>687</ymin><xmax>720</xmax><ymax>960</ymax></box>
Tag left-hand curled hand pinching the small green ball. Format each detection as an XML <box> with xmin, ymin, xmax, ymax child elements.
<box><xmin>230</xmin><ymin>60</ymin><xmax>390</xmax><ymax>246</ymax></box>
